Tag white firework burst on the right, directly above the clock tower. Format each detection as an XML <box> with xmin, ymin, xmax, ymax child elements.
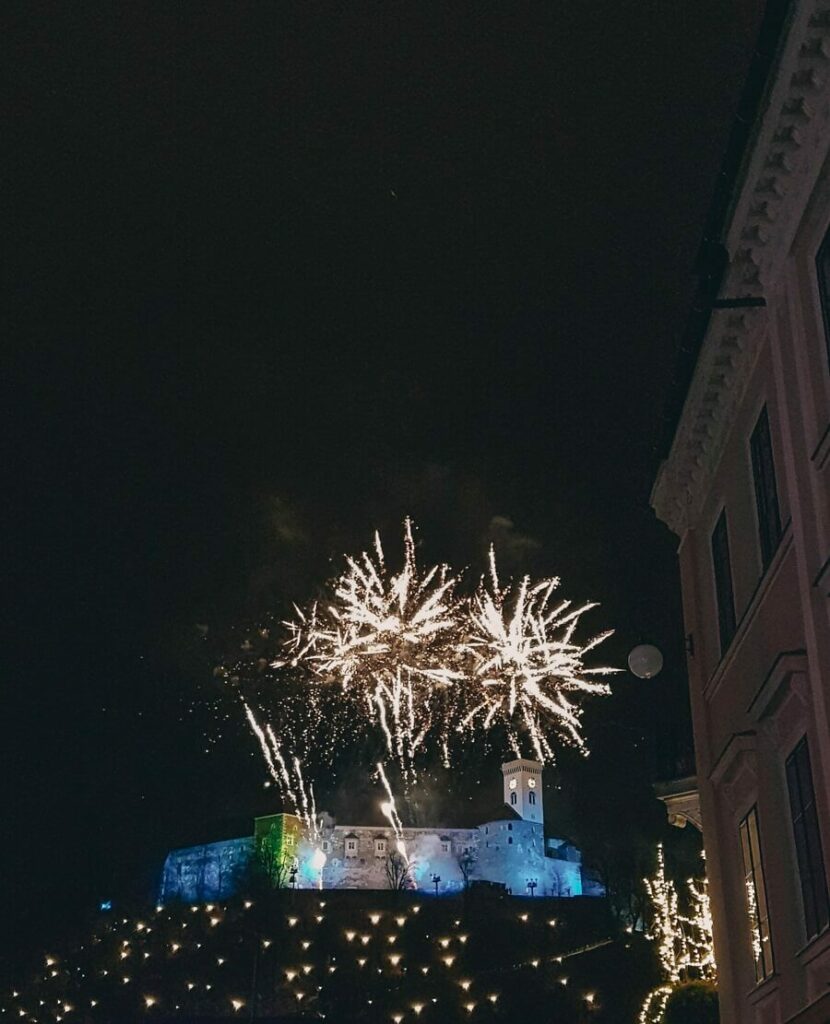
<box><xmin>457</xmin><ymin>549</ymin><xmax>616</xmax><ymax>762</ymax></box>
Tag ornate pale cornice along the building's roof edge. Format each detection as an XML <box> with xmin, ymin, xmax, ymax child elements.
<box><xmin>651</xmin><ymin>0</ymin><xmax>830</xmax><ymax>537</ymax></box>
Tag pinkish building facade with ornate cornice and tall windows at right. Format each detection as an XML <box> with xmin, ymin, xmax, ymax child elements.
<box><xmin>652</xmin><ymin>0</ymin><xmax>830</xmax><ymax>1024</ymax></box>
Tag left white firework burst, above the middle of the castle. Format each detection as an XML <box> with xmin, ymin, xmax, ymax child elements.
<box><xmin>273</xmin><ymin>519</ymin><xmax>465</xmax><ymax>782</ymax></box>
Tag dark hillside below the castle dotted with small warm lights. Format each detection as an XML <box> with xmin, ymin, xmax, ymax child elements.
<box><xmin>0</xmin><ymin>891</ymin><xmax>630</xmax><ymax>1024</ymax></box>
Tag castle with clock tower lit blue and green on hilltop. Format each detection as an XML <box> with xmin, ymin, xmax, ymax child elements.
<box><xmin>160</xmin><ymin>758</ymin><xmax>604</xmax><ymax>902</ymax></box>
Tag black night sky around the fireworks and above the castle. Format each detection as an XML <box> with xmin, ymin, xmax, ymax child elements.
<box><xmin>0</xmin><ymin>0</ymin><xmax>761</xmax><ymax>974</ymax></box>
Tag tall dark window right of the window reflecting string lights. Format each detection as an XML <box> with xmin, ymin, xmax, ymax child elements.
<box><xmin>787</xmin><ymin>736</ymin><xmax>830</xmax><ymax>939</ymax></box>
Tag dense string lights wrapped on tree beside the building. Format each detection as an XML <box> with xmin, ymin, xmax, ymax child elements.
<box><xmin>640</xmin><ymin>844</ymin><xmax>717</xmax><ymax>1024</ymax></box>
